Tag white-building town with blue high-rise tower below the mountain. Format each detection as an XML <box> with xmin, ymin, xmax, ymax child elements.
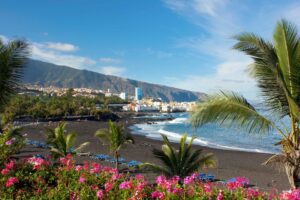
<box><xmin>19</xmin><ymin>84</ymin><xmax>196</xmax><ymax>113</ymax></box>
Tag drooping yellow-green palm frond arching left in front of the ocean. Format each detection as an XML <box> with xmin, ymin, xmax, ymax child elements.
<box><xmin>191</xmin><ymin>92</ymin><xmax>284</xmax><ymax>137</ymax></box>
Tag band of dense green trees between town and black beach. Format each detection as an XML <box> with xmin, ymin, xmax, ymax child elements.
<box><xmin>3</xmin><ymin>94</ymin><xmax>120</xmax><ymax>122</ymax></box>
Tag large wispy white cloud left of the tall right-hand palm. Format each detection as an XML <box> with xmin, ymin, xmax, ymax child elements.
<box><xmin>165</xmin><ymin>0</ymin><xmax>257</xmax><ymax>98</ymax></box>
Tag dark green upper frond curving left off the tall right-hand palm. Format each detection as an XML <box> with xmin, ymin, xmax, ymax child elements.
<box><xmin>233</xmin><ymin>33</ymin><xmax>290</xmax><ymax>117</ymax></box>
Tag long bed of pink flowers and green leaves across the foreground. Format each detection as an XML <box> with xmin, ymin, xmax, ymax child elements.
<box><xmin>0</xmin><ymin>154</ymin><xmax>300</xmax><ymax>200</ymax></box>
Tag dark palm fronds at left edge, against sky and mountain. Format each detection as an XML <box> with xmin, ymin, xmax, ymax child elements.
<box><xmin>0</xmin><ymin>39</ymin><xmax>29</xmax><ymax>110</ymax></box>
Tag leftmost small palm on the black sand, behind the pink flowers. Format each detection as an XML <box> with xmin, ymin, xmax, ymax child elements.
<box><xmin>46</xmin><ymin>123</ymin><xmax>89</xmax><ymax>158</ymax></box>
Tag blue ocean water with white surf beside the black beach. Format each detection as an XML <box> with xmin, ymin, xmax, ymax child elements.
<box><xmin>130</xmin><ymin>113</ymin><xmax>281</xmax><ymax>153</ymax></box>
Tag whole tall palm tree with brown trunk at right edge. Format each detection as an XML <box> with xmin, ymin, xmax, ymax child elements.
<box><xmin>192</xmin><ymin>20</ymin><xmax>300</xmax><ymax>188</ymax></box>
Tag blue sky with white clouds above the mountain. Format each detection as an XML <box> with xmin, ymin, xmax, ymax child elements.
<box><xmin>0</xmin><ymin>0</ymin><xmax>300</xmax><ymax>99</ymax></box>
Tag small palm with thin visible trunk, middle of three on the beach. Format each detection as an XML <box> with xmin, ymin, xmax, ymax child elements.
<box><xmin>95</xmin><ymin>121</ymin><xmax>134</xmax><ymax>169</ymax></box>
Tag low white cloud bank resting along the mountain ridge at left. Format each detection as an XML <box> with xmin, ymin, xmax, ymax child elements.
<box><xmin>31</xmin><ymin>43</ymin><xmax>96</xmax><ymax>69</ymax></box>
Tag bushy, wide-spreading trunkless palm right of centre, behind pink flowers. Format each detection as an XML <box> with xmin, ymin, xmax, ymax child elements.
<box><xmin>141</xmin><ymin>134</ymin><xmax>215</xmax><ymax>178</ymax></box>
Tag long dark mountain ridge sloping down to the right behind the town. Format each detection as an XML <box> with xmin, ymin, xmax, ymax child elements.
<box><xmin>23</xmin><ymin>60</ymin><xmax>205</xmax><ymax>102</ymax></box>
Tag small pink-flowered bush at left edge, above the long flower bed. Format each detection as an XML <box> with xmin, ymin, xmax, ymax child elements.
<box><xmin>0</xmin><ymin>127</ymin><xmax>25</xmax><ymax>166</ymax></box>
